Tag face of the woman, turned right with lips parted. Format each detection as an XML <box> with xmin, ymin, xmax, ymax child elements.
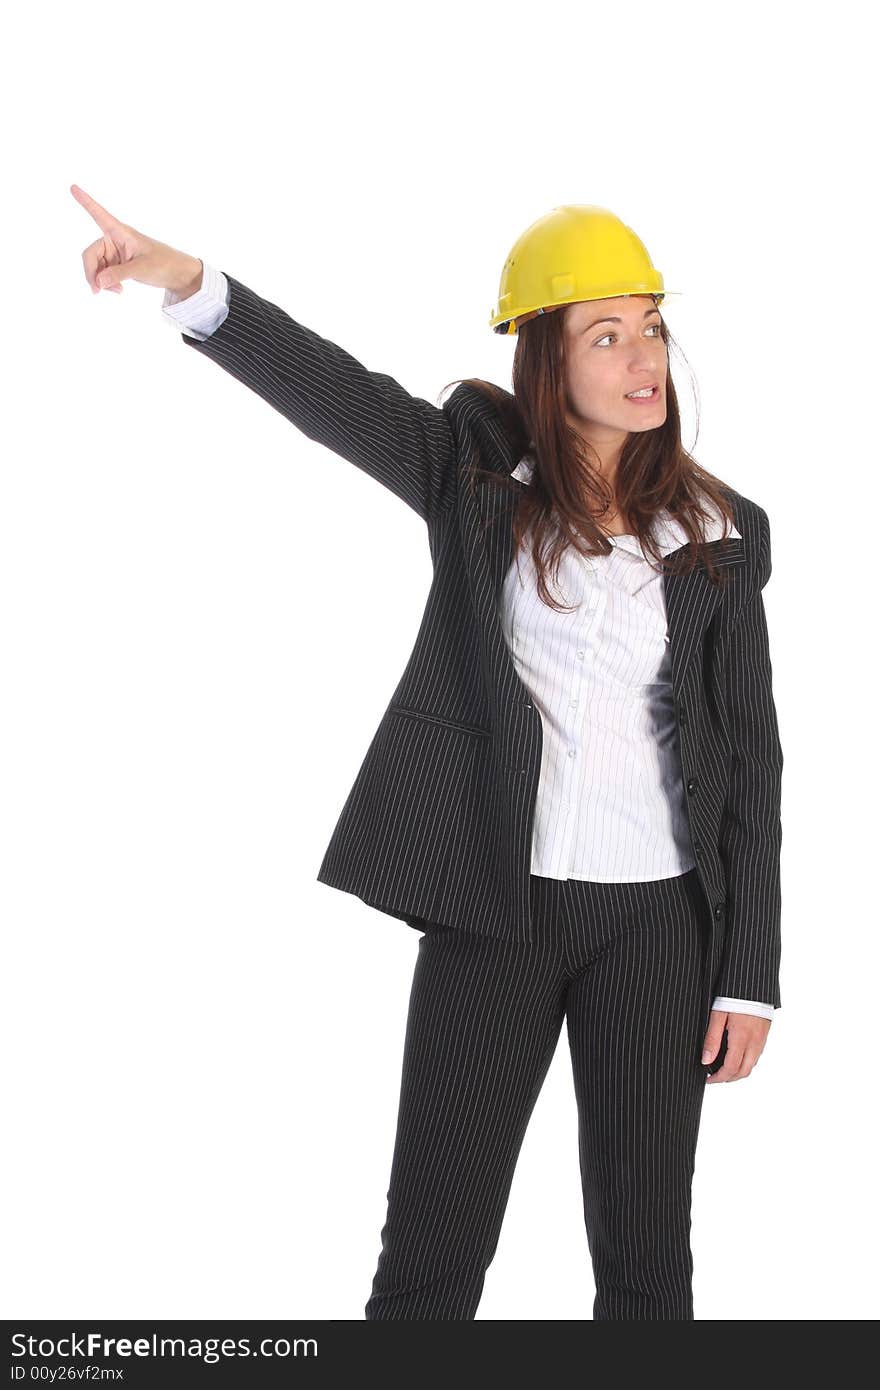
<box><xmin>563</xmin><ymin>295</ymin><xmax>667</xmax><ymax>443</ymax></box>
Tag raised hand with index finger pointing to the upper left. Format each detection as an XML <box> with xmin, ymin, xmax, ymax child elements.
<box><xmin>71</xmin><ymin>183</ymin><xmax>204</xmax><ymax>297</ymax></box>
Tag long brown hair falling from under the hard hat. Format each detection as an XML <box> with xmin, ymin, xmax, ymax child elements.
<box><xmin>441</xmin><ymin>306</ymin><xmax>735</xmax><ymax>612</ymax></box>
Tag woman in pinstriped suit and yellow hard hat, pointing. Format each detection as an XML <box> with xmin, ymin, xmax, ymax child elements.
<box><xmin>72</xmin><ymin>185</ymin><xmax>783</xmax><ymax>1319</ymax></box>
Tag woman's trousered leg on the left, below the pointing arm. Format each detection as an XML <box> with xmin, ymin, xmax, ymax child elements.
<box><xmin>366</xmin><ymin>927</ymin><xmax>564</xmax><ymax>1319</ymax></box>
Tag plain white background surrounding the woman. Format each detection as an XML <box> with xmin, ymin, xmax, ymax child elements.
<box><xmin>0</xmin><ymin>3</ymin><xmax>880</xmax><ymax>1319</ymax></box>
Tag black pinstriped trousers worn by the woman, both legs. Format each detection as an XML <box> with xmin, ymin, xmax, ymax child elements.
<box><xmin>366</xmin><ymin>869</ymin><xmax>708</xmax><ymax>1321</ymax></box>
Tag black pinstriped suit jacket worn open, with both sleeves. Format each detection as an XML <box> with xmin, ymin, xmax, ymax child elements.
<box><xmin>176</xmin><ymin>271</ymin><xmax>783</xmax><ymax>1012</ymax></box>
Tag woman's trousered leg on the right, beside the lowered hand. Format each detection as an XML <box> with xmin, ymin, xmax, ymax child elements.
<box><xmin>567</xmin><ymin>880</ymin><xmax>705</xmax><ymax>1321</ymax></box>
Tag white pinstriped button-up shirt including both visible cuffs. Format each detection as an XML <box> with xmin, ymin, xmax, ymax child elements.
<box><xmin>161</xmin><ymin>261</ymin><xmax>773</xmax><ymax>1017</ymax></box>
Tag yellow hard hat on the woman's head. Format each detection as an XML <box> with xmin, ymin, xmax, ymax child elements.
<box><xmin>489</xmin><ymin>203</ymin><xmax>678</xmax><ymax>334</ymax></box>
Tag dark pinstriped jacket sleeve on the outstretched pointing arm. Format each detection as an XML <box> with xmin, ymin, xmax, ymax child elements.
<box><xmin>181</xmin><ymin>271</ymin><xmax>456</xmax><ymax>521</ymax></box>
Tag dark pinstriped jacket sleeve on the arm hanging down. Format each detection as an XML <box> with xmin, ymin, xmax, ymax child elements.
<box><xmin>715</xmin><ymin>507</ymin><xmax>783</xmax><ymax>1008</ymax></box>
